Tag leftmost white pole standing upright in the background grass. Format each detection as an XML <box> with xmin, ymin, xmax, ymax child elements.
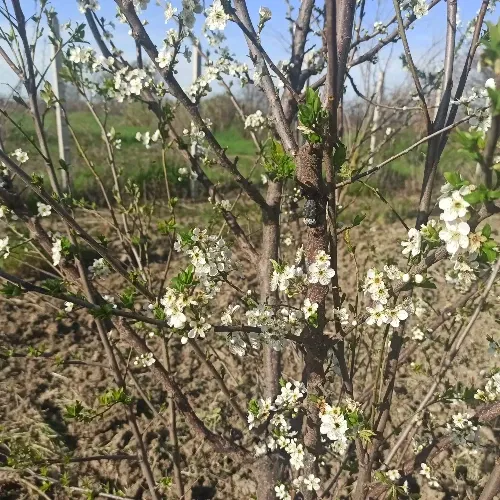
<box><xmin>51</xmin><ymin>15</ymin><xmax>70</xmax><ymax>191</ymax></box>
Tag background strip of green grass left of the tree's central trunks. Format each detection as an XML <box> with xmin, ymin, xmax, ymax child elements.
<box><xmin>1</xmin><ymin>104</ymin><xmax>260</xmax><ymax>205</ymax></box>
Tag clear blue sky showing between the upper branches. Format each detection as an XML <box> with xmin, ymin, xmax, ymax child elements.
<box><xmin>0</xmin><ymin>0</ymin><xmax>498</xmax><ymax>93</ymax></box>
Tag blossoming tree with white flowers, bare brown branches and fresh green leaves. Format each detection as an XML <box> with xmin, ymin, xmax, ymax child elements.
<box><xmin>0</xmin><ymin>0</ymin><xmax>500</xmax><ymax>500</ymax></box>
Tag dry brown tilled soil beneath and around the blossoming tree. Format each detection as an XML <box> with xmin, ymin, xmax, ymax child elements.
<box><xmin>0</xmin><ymin>208</ymin><xmax>498</xmax><ymax>500</ymax></box>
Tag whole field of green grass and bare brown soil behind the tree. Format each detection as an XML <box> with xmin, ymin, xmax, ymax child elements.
<box><xmin>0</xmin><ymin>98</ymin><xmax>498</xmax><ymax>500</ymax></box>
